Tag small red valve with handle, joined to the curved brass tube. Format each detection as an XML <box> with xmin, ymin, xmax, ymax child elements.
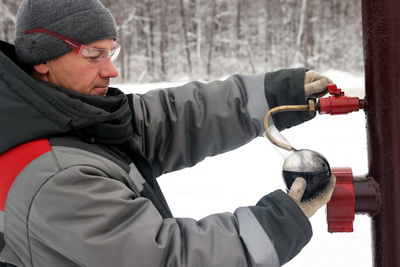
<box><xmin>318</xmin><ymin>84</ymin><xmax>365</xmax><ymax>115</ymax></box>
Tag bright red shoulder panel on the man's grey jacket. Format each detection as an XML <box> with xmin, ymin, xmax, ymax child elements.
<box><xmin>0</xmin><ymin>139</ymin><xmax>51</xmax><ymax>211</ymax></box>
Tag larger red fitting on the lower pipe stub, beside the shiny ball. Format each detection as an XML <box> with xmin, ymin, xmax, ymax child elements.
<box><xmin>326</xmin><ymin>168</ymin><xmax>356</xmax><ymax>233</ymax></box>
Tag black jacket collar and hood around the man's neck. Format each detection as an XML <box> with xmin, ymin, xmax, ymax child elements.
<box><xmin>0</xmin><ymin>42</ymin><xmax>133</xmax><ymax>153</ymax></box>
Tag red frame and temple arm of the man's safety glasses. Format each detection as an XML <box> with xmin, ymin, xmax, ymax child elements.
<box><xmin>25</xmin><ymin>28</ymin><xmax>121</xmax><ymax>66</ymax></box>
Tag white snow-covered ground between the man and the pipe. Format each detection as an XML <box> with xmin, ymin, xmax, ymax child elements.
<box><xmin>113</xmin><ymin>70</ymin><xmax>372</xmax><ymax>267</ymax></box>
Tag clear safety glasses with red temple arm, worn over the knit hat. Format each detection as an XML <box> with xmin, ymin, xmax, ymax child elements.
<box><xmin>26</xmin><ymin>29</ymin><xmax>121</xmax><ymax>66</ymax></box>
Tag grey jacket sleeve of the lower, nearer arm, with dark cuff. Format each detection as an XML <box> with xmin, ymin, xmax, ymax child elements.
<box><xmin>28</xmin><ymin>165</ymin><xmax>311</xmax><ymax>267</ymax></box>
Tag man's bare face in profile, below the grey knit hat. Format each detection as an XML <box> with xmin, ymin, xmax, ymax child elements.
<box><xmin>33</xmin><ymin>39</ymin><xmax>118</xmax><ymax>96</ymax></box>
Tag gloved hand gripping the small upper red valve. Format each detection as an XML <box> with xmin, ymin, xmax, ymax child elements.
<box><xmin>304</xmin><ymin>70</ymin><xmax>333</xmax><ymax>97</ymax></box>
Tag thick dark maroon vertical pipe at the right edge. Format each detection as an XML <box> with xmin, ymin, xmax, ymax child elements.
<box><xmin>362</xmin><ymin>0</ymin><xmax>400</xmax><ymax>267</ymax></box>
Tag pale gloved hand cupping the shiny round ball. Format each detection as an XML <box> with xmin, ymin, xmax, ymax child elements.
<box><xmin>288</xmin><ymin>175</ymin><xmax>336</xmax><ymax>218</ymax></box>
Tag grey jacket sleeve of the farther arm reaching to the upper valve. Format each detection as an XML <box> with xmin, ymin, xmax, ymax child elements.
<box><xmin>130</xmin><ymin>69</ymin><xmax>311</xmax><ymax>177</ymax></box>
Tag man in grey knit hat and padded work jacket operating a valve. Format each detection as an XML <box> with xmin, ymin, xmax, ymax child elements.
<box><xmin>0</xmin><ymin>0</ymin><xmax>335</xmax><ymax>267</ymax></box>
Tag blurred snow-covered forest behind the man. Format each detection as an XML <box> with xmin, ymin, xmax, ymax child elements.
<box><xmin>0</xmin><ymin>0</ymin><xmax>364</xmax><ymax>83</ymax></box>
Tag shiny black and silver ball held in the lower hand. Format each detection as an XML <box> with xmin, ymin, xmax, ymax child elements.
<box><xmin>282</xmin><ymin>149</ymin><xmax>332</xmax><ymax>201</ymax></box>
